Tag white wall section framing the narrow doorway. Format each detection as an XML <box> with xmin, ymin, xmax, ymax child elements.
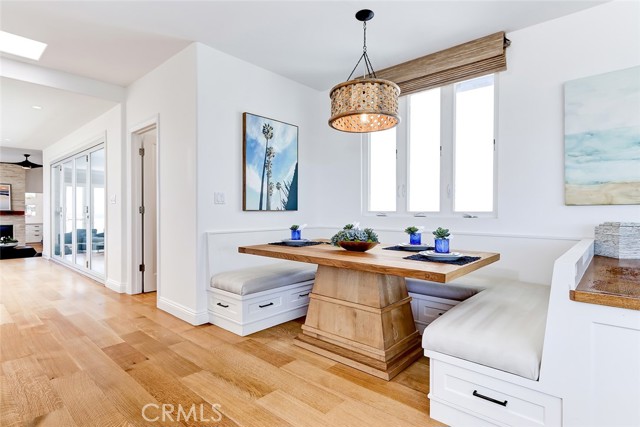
<box><xmin>123</xmin><ymin>44</ymin><xmax>201</xmax><ymax>323</ymax></box>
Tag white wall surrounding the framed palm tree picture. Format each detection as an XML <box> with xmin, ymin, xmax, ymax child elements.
<box><xmin>197</xmin><ymin>44</ymin><xmax>325</xmax><ymax>318</ymax></box>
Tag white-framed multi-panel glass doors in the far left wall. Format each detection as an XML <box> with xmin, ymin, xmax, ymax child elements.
<box><xmin>51</xmin><ymin>145</ymin><xmax>106</xmax><ymax>277</ymax></box>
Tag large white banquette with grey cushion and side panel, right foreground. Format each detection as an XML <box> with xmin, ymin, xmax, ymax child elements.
<box><xmin>423</xmin><ymin>240</ymin><xmax>640</xmax><ymax>427</ymax></box>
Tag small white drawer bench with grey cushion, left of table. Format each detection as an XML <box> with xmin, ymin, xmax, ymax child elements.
<box><xmin>208</xmin><ymin>262</ymin><xmax>316</xmax><ymax>336</ymax></box>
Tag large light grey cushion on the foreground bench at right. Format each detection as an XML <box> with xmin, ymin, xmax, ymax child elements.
<box><xmin>422</xmin><ymin>282</ymin><xmax>550</xmax><ymax>381</ymax></box>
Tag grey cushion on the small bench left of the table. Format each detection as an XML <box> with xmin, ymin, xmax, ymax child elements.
<box><xmin>211</xmin><ymin>263</ymin><xmax>316</xmax><ymax>295</ymax></box>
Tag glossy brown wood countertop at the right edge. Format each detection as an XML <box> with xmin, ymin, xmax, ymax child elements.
<box><xmin>569</xmin><ymin>255</ymin><xmax>640</xmax><ymax>310</ymax></box>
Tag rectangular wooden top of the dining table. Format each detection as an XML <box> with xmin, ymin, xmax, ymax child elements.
<box><xmin>238</xmin><ymin>244</ymin><xmax>500</xmax><ymax>283</ymax></box>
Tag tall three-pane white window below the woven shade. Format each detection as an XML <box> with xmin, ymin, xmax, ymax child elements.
<box><xmin>365</xmin><ymin>74</ymin><xmax>495</xmax><ymax>216</ymax></box>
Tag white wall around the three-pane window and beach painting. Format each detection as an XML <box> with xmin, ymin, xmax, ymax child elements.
<box><xmin>304</xmin><ymin>2</ymin><xmax>640</xmax><ymax>283</ymax></box>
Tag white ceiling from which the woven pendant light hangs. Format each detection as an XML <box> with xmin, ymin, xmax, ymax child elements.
<box><xmin>0</xmin><ymin>0</ymin><xmax>603</xmax><ymax>147</ymax></box>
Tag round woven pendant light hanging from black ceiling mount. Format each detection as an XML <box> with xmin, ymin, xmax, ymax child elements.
<box><xmin>329</xmin><ymin>9</ymin><xmax>400</xmax><ymax>133</ymax></box>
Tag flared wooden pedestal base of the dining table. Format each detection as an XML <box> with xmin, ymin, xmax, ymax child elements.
<box><xmin>295</xmin><ymin>265</ymin><xmax>422</xmax><ymax>380</ymax></box>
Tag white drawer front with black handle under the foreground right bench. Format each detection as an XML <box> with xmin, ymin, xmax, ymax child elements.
<box><xmin>430</xmin><ymin>359</ymin><xmax>562</xmax><ymax>427</ymax></box>
